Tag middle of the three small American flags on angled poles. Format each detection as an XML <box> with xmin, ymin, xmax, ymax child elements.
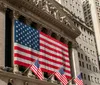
<box><xmin>55</xmin><ymin>68</ymin><xmax>68</xmax><ymax>85</ymax></box>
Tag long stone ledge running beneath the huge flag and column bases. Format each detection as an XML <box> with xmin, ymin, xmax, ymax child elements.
<box><xmin>0</xmin><ymin>71</ymin><xmax>57</xmax><ymax>85</ymax></box>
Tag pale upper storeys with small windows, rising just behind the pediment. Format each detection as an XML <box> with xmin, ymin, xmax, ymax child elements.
<box><xmin>56</xmin><ymin>0</ymin><xmax>84</xmax><ymax>21</ymax></box>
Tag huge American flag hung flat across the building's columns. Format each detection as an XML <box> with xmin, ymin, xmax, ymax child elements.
<box><xmin>14</xmin><ymin>20</ymin><xmax>71</xmax><ymax>78</ymax></box>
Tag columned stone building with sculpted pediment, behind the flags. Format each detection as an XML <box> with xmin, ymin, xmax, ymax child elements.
<box><xmin>0</xmin><ymin>0</ymin><xmax>80</xmax><ymax>85</ymax></box>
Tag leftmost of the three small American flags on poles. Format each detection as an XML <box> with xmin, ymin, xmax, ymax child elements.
<box><xmin>30</xmin><ymin>60</ymin><xmax>44</xmax><ymax>80</ymax></box>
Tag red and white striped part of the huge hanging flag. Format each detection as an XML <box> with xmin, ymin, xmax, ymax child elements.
<box><xmin>14</xmin><ymin>26</ymin><xmax>71</xmax><ymax>78</ymax></box>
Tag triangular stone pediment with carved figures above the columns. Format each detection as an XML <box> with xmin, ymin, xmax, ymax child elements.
<box><xmin>3</xmin><ymin>0</ymin><xmax>80</xmax><ymax>39</ymax></box>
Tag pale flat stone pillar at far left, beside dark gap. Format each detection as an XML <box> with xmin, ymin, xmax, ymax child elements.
<box><xmin>0</xmin><ymin>2</ymin><xmax>6</xmax><ymax>67</ymax></box>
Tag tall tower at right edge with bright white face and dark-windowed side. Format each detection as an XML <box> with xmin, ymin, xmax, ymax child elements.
<box><xmin>83</xmin><ymin>0</ymin><xmax>100</xmax><ymax>63</ymax></box>
